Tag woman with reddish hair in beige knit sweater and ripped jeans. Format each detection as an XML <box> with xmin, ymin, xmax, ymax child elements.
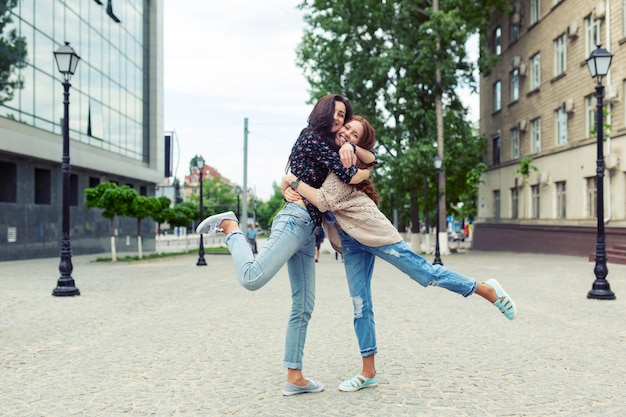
<box><xmin>281</xmin><ymin>116</ymin><xmax>517</xmax><ymax>391</ymax></box>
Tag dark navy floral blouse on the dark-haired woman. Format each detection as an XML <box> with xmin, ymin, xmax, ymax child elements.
<box><xmin>290</xmin><ymin>129</ymin><xmax>357</xmax><ymax>226</ymax></box>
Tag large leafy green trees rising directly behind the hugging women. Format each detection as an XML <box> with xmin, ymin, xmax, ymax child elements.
<box><xmin>297</xmin><ymin>0</ymin><xmax>510</xmax><ymax>224</ymax></box>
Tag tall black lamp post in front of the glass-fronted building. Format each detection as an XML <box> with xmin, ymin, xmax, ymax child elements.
<box><xmin>52</xmin><ymin>42</ymin><xmax>80</xmax><ymax>296</ymax></box>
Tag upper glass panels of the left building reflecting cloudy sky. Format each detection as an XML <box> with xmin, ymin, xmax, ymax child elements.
<box><xmin>0</xmin><ymin>0</ymin><xmax>147</xmax><ymax>160</ymax></box>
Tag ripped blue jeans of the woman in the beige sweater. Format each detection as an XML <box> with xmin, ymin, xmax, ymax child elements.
<box><xmin>339</xmin><ymin>229</ymin><xmax>476</xmax><ymax>356</ymax></box>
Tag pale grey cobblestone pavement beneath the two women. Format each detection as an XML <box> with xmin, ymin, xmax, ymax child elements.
<box><xmin>0</xmin><ymin>251</ymin><xmax>626</xmax><ymax>417</ymax></box>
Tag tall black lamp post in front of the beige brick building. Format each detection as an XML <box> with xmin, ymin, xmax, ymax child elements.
<box><xmin>587</xmin><ymin>45</ymin><xmax>615</xmax><ymax>300</ymax></box>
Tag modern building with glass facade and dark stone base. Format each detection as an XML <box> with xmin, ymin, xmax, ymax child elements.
<box><xmin>0</xmin><ymin>0</ymin><xmax>164</xmax><ymax>260</ymax></box>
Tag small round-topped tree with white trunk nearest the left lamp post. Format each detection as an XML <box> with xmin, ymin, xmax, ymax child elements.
<box><xmin>85</xmin><ymin>182</ymin><xmax>137</xmax><ymax>262</ymax></box>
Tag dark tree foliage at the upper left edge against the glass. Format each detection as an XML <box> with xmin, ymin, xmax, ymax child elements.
<box><xmin>0</xmin><ymin>0</ymin><xmax>28</xmax><ymax>104</ymax></box>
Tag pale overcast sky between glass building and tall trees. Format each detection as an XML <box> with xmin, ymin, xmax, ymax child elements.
<box><xmin>164</xmin><ymin>0</ymin><xmax>311</xmax><ymax>200</ymax></box>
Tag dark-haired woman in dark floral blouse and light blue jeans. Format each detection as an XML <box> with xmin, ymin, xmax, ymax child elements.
<box><xmin>196</xmin><ymin>94</ymin><xmax>374</xmax><ymax>395</ymax></box>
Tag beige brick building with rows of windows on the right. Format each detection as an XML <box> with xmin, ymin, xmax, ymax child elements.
<box><xmin>473</xmin><ymin>0</ymin><xmax>626</xmax><ymax>258</ymax></box>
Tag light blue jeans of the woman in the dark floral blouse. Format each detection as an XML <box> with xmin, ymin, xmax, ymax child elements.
<box><xmin>226</xmin><ymin>203</ymin><xmax>315</xmax><ymax>369</ymax></box>
